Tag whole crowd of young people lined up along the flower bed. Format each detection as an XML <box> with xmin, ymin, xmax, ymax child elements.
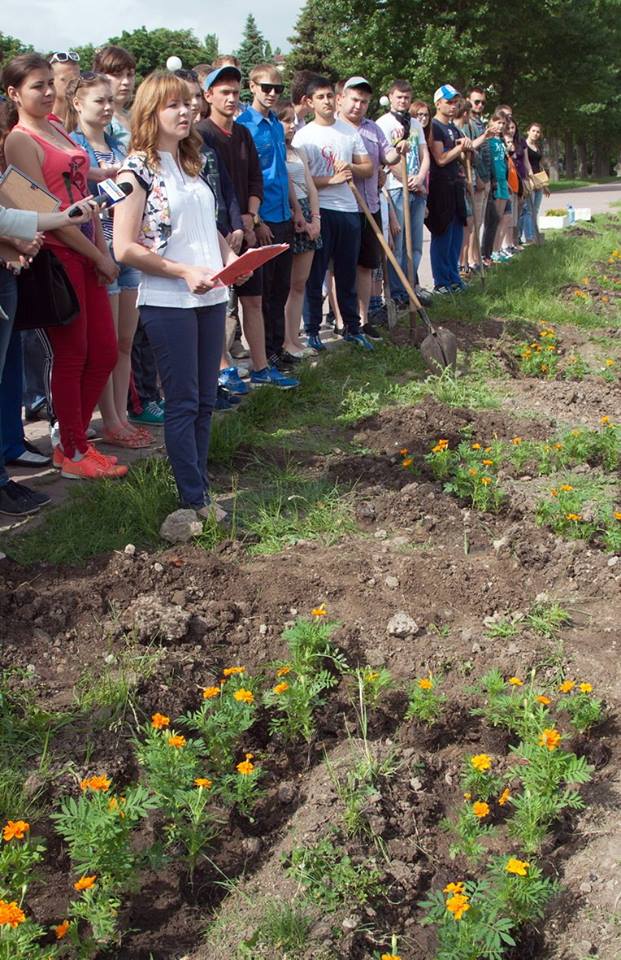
<box><xmin>0</xmin><ymin>46</ymin><xmax>542</xmax><ymax>519</ymax></box>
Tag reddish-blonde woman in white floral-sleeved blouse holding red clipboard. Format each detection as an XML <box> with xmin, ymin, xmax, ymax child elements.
<box><xmin>114</xmin><ymin>72</ymin><xmax>250</xmax><ymax>520</ymax></box>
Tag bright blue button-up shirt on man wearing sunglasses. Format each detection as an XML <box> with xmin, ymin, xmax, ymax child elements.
<box><xmin>235</xmin><ymin>107</ymin><xmax>291</xmax><ymax>223</ymax></box>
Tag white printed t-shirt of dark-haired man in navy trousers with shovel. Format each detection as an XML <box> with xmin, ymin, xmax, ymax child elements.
<box><xmin>293</xmin><ymin>120</ymin><xmax>367</xmax><ymax>213</ymax></box>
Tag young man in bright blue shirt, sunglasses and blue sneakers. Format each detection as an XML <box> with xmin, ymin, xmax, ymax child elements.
<box><xmin>236</xmin><ymin>63</ymin><xmax>300</xmax><ymax>370</ymax></box>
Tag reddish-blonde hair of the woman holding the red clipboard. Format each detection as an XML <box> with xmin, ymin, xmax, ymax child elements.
<box><xmin>129</xmin><ymin>70</ymin><xmax>203</xmax><ymax>177</ymax></box>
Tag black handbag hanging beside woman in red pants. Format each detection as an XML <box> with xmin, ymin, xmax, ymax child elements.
<box><xmin>13</xmin><ymin>249</ymin><xmax>80</xmax><ymax>330</ymax></box>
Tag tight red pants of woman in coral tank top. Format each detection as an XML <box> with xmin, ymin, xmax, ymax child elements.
<box><xmin>46</xmin><ymin>246</ymin><xmax>118</xmax><ymax>457</ymax></box>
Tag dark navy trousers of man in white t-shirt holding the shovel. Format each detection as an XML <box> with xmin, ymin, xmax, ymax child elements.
<box><xmin>304</xmin><ymin>208</ymin><xmax>362</xmax><ymax>336</ymax></box>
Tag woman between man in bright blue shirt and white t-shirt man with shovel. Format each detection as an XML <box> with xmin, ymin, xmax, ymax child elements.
<box><xmin>278</xmin><ymin>103</ymin><xmax>321</xmax><ymax>357</ymax></box>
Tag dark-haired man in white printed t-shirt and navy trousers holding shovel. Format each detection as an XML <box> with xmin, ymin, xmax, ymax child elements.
<box><xmin>293</xmin><ymin>77</ymin><xmax>373</xmax><ymax>350</ymax></box>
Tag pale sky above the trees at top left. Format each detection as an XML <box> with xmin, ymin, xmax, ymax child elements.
<box><xmin>1</xmin><ymin>0</ymin><xmax>303</xmax><ymax>53</ymax></box>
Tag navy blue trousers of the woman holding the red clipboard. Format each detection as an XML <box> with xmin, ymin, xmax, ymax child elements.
<box><xmin>140</xmin><ymin>303</ymin><xmax>226</xmax><ymax>509</ymax></box>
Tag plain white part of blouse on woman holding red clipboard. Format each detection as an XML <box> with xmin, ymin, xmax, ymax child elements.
<box><xmin>137</xmin><ymin>152</ymin><xmax>228</xmax><ymax>309</ymax></box>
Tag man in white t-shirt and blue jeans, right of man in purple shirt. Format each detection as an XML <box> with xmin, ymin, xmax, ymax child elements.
<box><xmin>377</xmin><ymin>80</ymin><xmax>429</xmax><ymax>303</ymax></box>
